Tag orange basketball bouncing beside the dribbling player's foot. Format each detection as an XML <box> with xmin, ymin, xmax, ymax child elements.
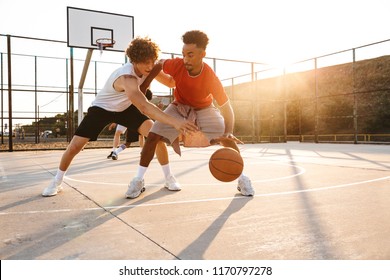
<box><xmin>209</xmin><ymin>148</ymin><xmax>244</xmax><ymax>182</ymax></box>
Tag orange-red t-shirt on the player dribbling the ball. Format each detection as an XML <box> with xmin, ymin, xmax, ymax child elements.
<box><xmin>163</xmin><ymin>58</ymin><xmax>228</xmax><ymax>109</ymax></box>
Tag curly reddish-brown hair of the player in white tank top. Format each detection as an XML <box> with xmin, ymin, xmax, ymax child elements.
<box><xmin>126</xmin><ymin>37</ymin><xmax>160</xmax><ymax>63</ymax></box>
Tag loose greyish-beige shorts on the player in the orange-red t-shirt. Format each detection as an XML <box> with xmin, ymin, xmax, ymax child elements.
<box><xmin>150</xmin><ymin>104</ymin><xmax>225</xmax><ymax>144</ymax></box>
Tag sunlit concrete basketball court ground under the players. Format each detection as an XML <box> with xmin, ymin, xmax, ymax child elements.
<box><xmin>0</xmin><ymin>142</ymin><xmax>390</xmax><ymax>260</ymax></box>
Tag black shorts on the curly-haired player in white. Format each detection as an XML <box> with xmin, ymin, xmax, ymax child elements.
<box><xmin>75</xmin><ymin>105</ymin><xmax>149</xmax><ymax>142</ymax></box>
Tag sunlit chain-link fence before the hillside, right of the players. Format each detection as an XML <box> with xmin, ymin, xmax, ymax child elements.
<box><xmin>224</xmin><ymin>40</ymin><xmax>390</xmax><ymax>143</ymax></box>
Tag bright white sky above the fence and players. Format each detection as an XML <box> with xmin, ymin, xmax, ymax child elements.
<box><xmin>0</xmin><ymin>0</ymin><xmax>390</xmax><ymax>65</ymax></box>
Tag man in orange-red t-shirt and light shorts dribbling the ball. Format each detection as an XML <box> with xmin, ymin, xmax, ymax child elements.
<box><xmin>126</xmin><ymin>30</ymin><xmax>254</xmax><ymax>198</ymax></box>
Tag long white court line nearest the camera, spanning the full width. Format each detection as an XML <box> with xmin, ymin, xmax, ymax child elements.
<box><xmin>0</xmin><ymin>176</ymin><xmax>390</xmax><ymax>216</ymax></box>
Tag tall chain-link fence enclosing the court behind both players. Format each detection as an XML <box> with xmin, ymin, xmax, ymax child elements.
<box><xmin>0</xmin><ymin>35</ymin><xmax>390</xmax><ymax>151</ymax></box>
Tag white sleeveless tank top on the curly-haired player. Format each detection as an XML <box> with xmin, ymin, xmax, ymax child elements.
<box><xmin>91</xmin><ymin>63</ymin><xmax>146</xmax><ymax>112</ymax></box>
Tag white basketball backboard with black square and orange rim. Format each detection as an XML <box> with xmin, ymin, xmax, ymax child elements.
<box><xmin>67</xmin><ymin>7</ymin><xmax>134</xmax><ymax>52</ymax></box>
